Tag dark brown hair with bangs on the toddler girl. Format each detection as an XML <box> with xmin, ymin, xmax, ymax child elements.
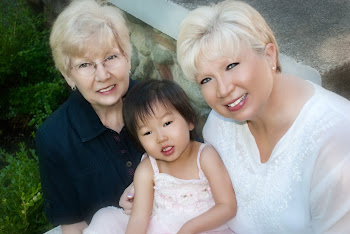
<box><xmin>123</xmin><ymin>79</ymin><xmax>197</xmax><ymax>150</ymax></box>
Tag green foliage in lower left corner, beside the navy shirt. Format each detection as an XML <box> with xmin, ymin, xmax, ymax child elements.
<box><xmin>0</xmin><ymin>143</ymin><xmax>52</xmax><ymax>234</ymax></box>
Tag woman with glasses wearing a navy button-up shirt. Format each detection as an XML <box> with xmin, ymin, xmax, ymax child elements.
<box><xmin>36</xmin><ymin>0</ymin><xmax>142</xmax><ymax>233</ymax></box>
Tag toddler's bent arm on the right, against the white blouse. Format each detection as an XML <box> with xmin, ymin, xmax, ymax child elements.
<box><xmin>178</xmin><ymin>146</ymin><xmax>237</xmax><ymax>234</ymax></box>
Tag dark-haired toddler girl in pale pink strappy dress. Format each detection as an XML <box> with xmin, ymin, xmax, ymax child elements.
<box><xmin>84</xmin><ymin>80</ymin><xmax>237</xmax><ymax>234</ymax></box>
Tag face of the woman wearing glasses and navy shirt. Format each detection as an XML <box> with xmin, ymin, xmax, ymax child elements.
<box><xmin>64</xmin><ymin>46</ymin><xmax>130</xmax><ymax>110</ymax></box>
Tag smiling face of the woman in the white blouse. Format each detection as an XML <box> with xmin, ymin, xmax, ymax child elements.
<box><xmin>196</xmin><ymin>44</ymin><xmax>276</xmax><ymax>121</ymax></box>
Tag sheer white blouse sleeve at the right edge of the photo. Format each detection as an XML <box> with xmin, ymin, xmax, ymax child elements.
<box><xmin>310</xmin><ymin>126</ymin><xmax>350</xmax><ymax>233</ymax></box>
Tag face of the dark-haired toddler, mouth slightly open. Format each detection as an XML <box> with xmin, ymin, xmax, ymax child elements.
<box><xmin>137</xmin><ymin>104</ymin><xmax>194</xmax><ymax>162</ymax></box>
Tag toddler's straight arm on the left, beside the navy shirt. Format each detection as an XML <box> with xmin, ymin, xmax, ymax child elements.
<box><xmin>126</xmin><ymin>158</ymin><xmax>154</xmax><ymax>234</ymax></box>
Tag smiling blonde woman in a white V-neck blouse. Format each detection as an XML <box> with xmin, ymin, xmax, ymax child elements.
<box><xmin>177</xmin><ymin>1</ymin><xmax>350</xmax><ymax>233</ymax></box>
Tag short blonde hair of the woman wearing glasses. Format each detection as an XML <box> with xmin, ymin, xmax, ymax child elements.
<box><xmin>50</xmin><ymin>0</ymin><xmax>131</xmax><ymax>74</ymax></box>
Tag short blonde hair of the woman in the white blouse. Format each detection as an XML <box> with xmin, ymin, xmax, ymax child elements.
<box><xmin>177</xmin><ymin>0</ymin><xmax>281</xmax><ymax>81</ymax></box>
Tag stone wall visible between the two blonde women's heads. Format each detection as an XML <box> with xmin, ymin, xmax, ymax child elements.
<box><xmin>125</xmin><ymin>13</ymin><xmax>210</xmax><ymax>132</ymax></box>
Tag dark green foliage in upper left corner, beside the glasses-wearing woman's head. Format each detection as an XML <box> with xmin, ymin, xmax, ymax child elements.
<box><xmin>0</xmin><ymin>0</ymin><xmax>68</xmax><ymax>127</ymax></box>
